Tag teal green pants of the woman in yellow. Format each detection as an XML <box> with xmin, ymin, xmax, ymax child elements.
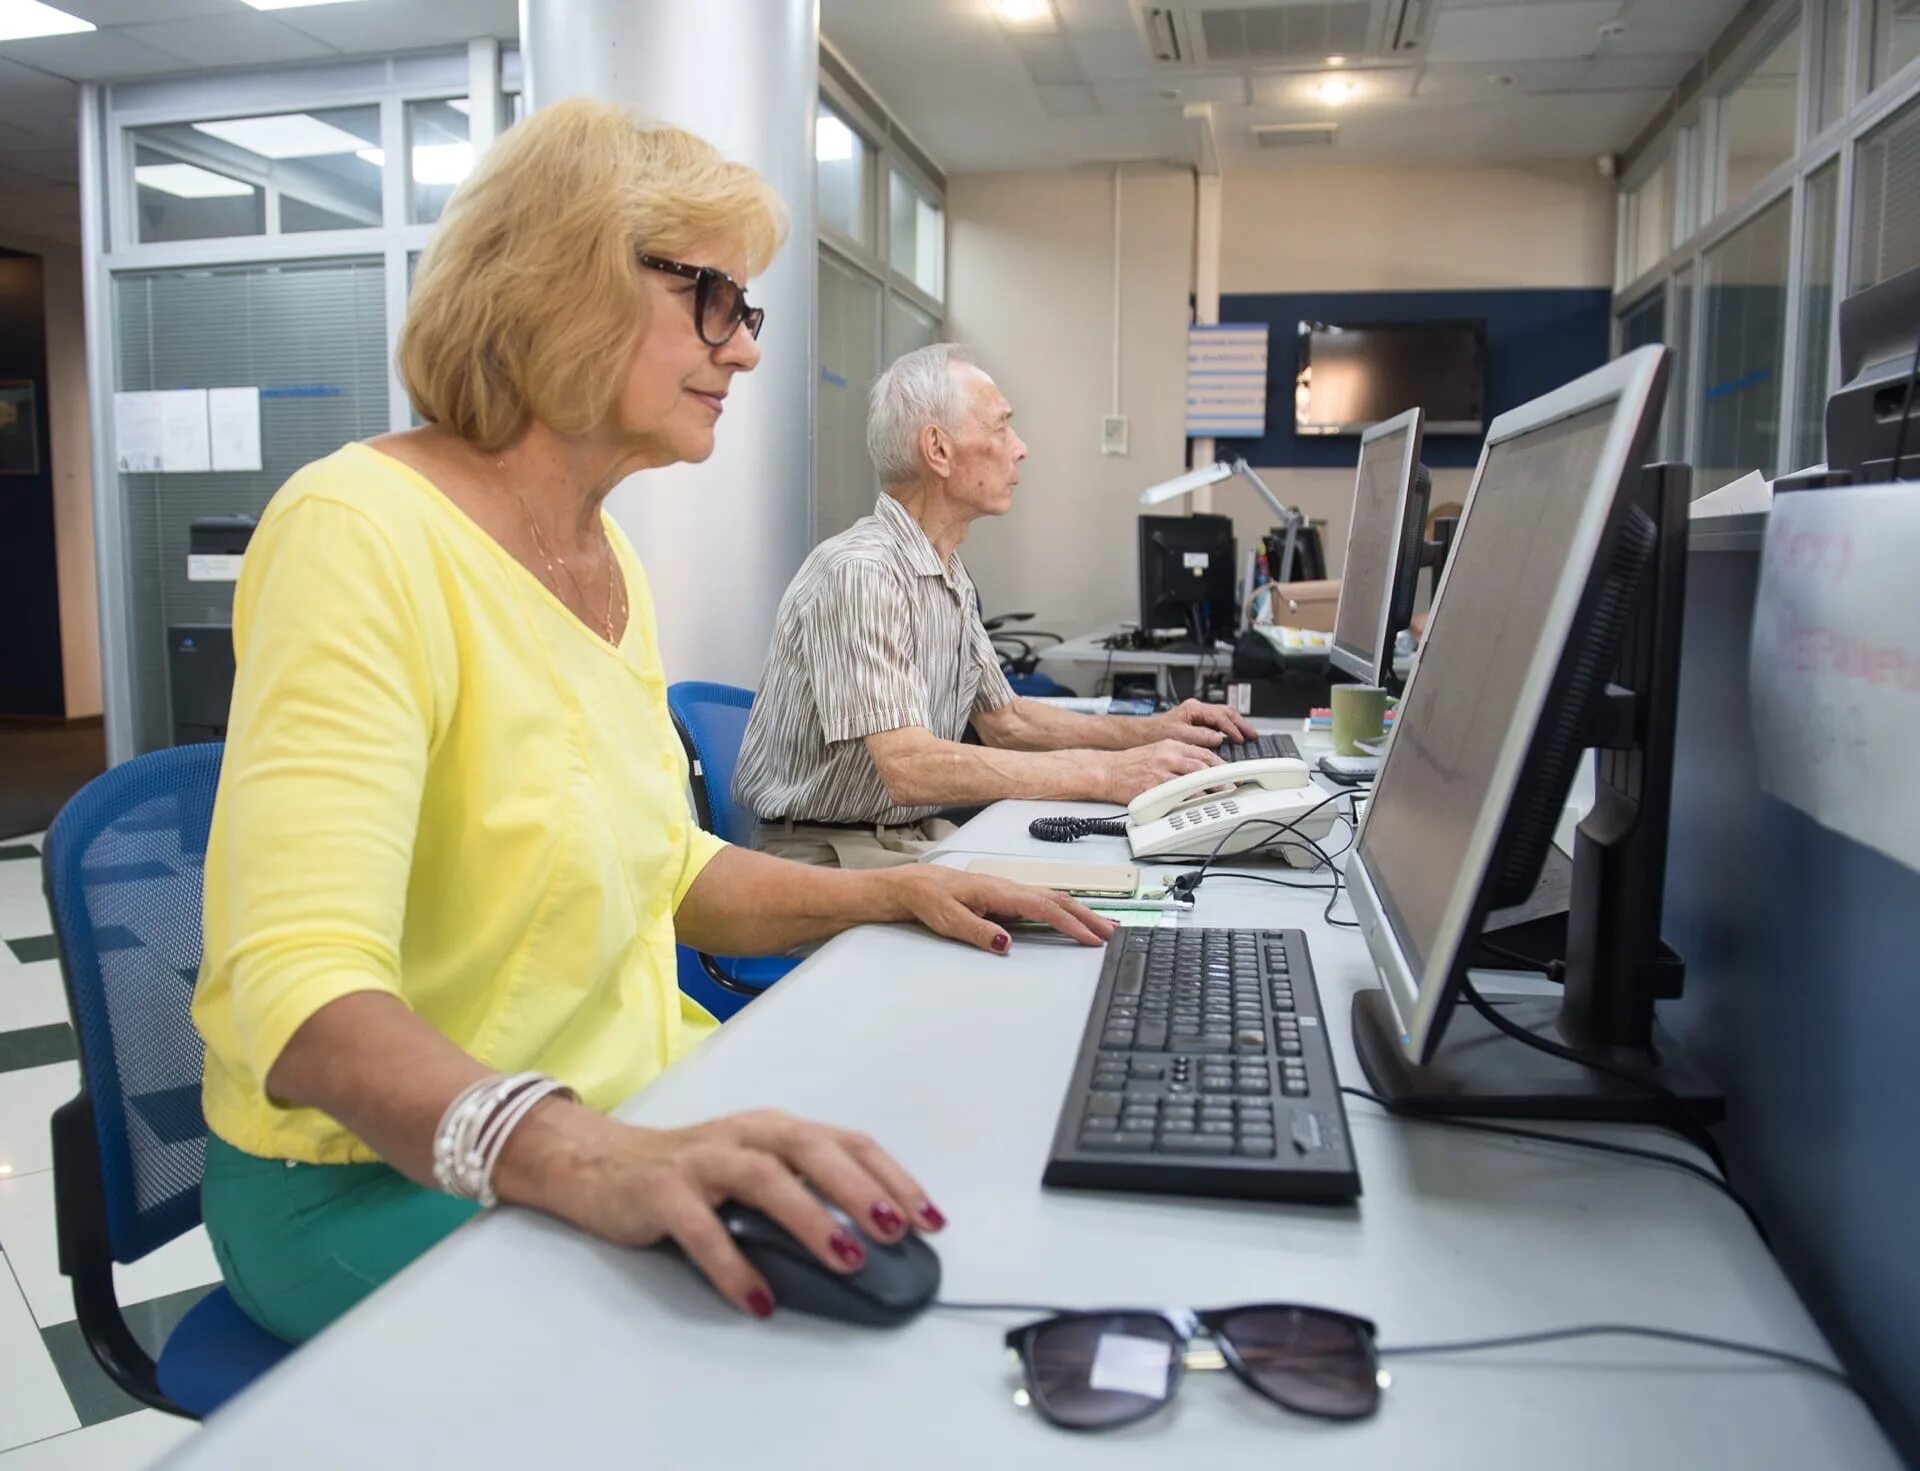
<box><xmin>200</xmin><ymin>1135</ymin><xmax>480</xmax><ymax>1342</ymax></box>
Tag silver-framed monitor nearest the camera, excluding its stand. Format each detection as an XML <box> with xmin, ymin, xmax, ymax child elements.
<box><xmin>1348</xmin><ymin>346</ymin><xmax>1667</xmax><ymax>1062</ymax></box>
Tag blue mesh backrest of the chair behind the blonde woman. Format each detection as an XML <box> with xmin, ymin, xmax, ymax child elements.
<box><xmin>44</xmin><ymin>745</ymin><xmax>223</xmax><ymax>1262</ymax></box>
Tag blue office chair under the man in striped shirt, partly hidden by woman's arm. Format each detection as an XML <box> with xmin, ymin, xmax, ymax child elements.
<box><xmin>666</xmin><ymin>680</ymin><xmax>801</xmax><ymax>1022</ymax></box>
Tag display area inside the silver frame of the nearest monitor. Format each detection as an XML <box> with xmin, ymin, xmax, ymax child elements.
<box><xmin>1359</xmin><ymin>403</ymin><xmax>1617</xmax><ymax>976</ymax></box>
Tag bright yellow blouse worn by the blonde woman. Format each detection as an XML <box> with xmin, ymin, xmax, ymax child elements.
<box><xmin>194</xmin><ymin>444</ymin><xmax>722</xmax><ymax>1164</ymax></box>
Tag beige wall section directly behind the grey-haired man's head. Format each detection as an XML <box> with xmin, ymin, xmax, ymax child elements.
<box><xmin>947</xmin><ymin>171</ymin><xmax>1194</xmax><ymax>636</ymax></box>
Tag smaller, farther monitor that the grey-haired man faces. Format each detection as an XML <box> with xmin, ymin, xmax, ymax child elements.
<box><xmin>1332</xmin><ymin>409</ymin><xmax>1430</xmax><ymax>684</ymax></box>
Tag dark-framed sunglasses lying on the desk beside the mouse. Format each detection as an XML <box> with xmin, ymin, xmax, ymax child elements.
<box><xmin>1006</xmin><ymin>1302</ymin><xmax>1386</xmax><ymax>1431</ymax></box>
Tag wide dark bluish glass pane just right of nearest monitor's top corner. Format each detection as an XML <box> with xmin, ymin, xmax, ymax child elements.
<box><xmin>1695</xmin><ymin>196</ymin><xmax>1793</xmax><ymax>492</ymax></box>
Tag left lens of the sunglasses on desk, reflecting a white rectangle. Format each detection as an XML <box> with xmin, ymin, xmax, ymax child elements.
<box><xmin>1021</xmin><ymin>1314</ymin><xmax>1185</xmax><ymax>1431</ymax></box>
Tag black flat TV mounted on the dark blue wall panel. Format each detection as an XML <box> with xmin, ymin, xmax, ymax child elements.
<box><xmin>1294</xmin><ymin>321</ymin><xmax>1486</xmax><ymax>436</ymax></box>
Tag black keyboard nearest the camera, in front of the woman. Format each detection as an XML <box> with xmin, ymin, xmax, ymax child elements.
<box><xmin>1043</xmin><ymin>929</ymin><xmax>1359</xmax><ymax>1202</ymax></box>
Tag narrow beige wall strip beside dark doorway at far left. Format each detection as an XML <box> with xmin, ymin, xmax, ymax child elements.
<box><xmin>0</xmin><ymin>230</ymin><xmax>100</xmax><ymax>720</ymax></box>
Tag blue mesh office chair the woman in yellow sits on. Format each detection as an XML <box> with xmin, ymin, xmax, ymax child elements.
<box><xmin>42</xmin><ymin>745</ymin><xmax>292</xmax><ymax>1419</ymax></box>
